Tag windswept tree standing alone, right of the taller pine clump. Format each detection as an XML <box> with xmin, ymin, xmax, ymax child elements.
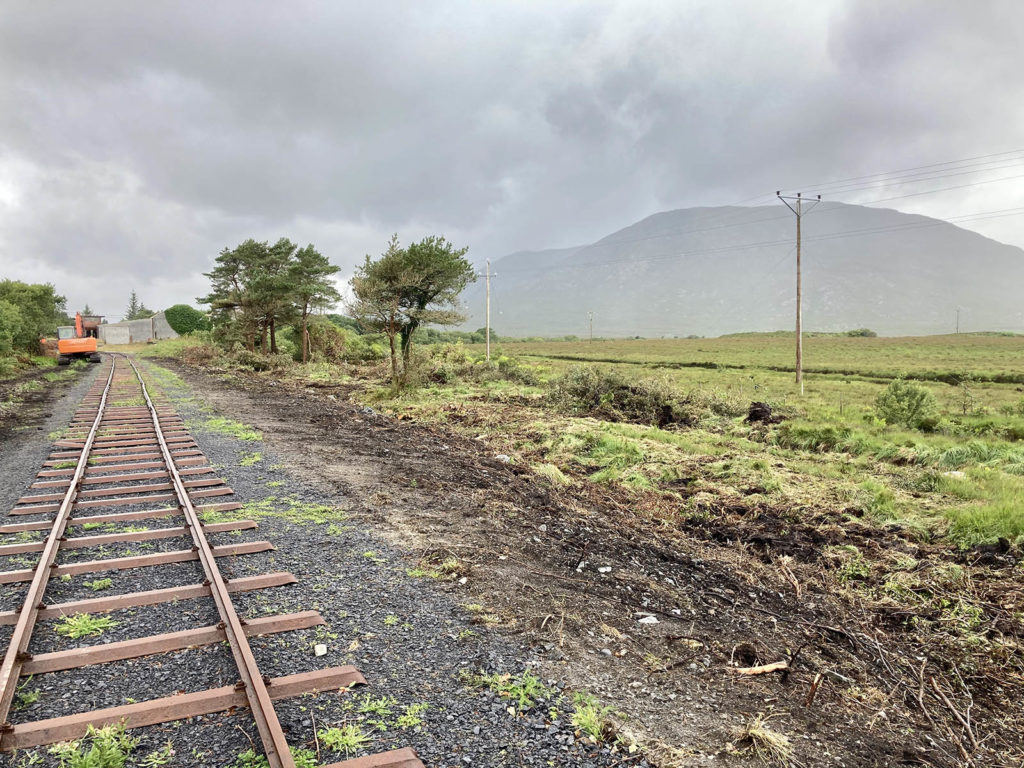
<box><xmin>348</xmin><ymin>234</ymin><xmax>476</xmax><ymax>388</ymax></box>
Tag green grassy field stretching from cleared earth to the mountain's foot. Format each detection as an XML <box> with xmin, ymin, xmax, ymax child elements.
<box><xmin>136</xmin><ymin>334</ymin><xmax>1024</xmax><ymax>548</ymax></box>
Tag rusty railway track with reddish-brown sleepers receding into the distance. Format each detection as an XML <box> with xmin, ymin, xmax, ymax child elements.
<box><xmin>0</xmin><ymin>355</ymin><xmax>423</xmax><ymax>768</ymax></box>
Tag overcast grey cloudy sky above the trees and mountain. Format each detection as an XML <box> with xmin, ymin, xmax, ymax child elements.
<box><xmin>0</xmin><ymin>0</ymin><xmax>1024</xmax><ymax>319</ymax></box>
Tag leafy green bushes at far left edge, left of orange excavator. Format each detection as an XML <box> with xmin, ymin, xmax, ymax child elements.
<box><xmin>0</xmin><ymin>280</ymin><xmax>67</xmax><ymax>355</ymax></box>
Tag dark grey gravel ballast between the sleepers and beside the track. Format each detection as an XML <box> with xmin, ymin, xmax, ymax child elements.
<box><xmin>0</xmin><ymin>364</ymin><xmax>646</xmax><ymax>768</ymax></box>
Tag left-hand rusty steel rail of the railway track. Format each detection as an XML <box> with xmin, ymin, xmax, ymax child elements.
<box><xmin>0</xmin><ymin>357</ymin><xmax>117</xmax><ymax>730</ymax></box>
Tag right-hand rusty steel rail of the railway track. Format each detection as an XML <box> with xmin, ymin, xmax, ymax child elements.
<box><xmin>124</xmin><ymin>358</ymin><xmax>295</xmax><ymax>768</ymax></box>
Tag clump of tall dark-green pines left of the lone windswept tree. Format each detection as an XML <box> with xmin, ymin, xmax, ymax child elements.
<box><xmin>199</xmin><ymin>238</ymin><xmax>341</xmax><ymax>362</ymax></box>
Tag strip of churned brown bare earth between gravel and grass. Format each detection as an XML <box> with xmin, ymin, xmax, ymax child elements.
<box><xmin>153</xmin><ymin>361</ymin><xmax>1024</xmax><ymax>766</ymax></box>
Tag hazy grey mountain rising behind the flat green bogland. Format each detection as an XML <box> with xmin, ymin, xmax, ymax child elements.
<box><xmin>463</xmin><ymin>202</ymin><xmax>1024</xmax><ymax>337</ymax></box>
